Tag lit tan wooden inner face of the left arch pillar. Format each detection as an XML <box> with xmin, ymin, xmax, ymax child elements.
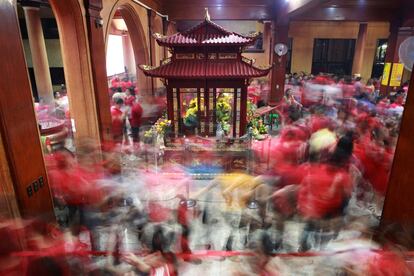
<box><xmin>49</xmin><ymin>0</ymin><xmax>100</xmax><ymax>142</ymax></box>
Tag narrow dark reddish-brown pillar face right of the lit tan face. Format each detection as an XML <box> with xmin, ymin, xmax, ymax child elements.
<box><xmin>85</xmin><ymin>0</ymin><xmax>112</xmax><ymax>141</ymax></box>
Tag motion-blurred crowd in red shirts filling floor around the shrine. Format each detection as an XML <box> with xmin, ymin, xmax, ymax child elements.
<box><xmin>0</xmin><ymin>74</ymin><xmax>414</xmax><ymax>275</ymax></box>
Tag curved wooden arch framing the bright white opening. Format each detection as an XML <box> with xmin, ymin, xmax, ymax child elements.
<box><xmin>105</xmin><ymin>0</ymin><xmax>150</xmax><ymax>94</ymax></box>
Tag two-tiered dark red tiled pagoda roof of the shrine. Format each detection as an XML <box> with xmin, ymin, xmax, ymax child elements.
<box><xmin>140</xmin><ymin>8</ymin><xmax>271</xmax><ymax>79</ymax></box>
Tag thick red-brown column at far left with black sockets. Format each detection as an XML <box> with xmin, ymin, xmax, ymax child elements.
<box><xmin>0</xmin><ymin>1</ymin><xmax>54</xmax><ymax>220</ymax></box>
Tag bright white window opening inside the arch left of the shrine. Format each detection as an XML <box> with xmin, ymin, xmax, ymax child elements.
<box><xmin>106</xmin><ymin>35</ymin><xmax>125</xmax><ymax>76</ymax></box>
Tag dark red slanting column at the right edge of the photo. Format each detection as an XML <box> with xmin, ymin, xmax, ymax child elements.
<box><xmin>381</xmin><ymin>66</ymin><xmax>414</xmax><ymax>229</ymax></box>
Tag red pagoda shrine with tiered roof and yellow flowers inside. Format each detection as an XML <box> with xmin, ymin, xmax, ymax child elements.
<box><xmin>140</xmin><ymin>9</ymin><xmax>271</xmax><ymax>137</ymax></box>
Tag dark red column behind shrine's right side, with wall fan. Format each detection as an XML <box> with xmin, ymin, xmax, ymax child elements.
<box><xmin>269</xmin><ymin>22</ymin><xmax>289</xmax><ymax>105</ymax></box>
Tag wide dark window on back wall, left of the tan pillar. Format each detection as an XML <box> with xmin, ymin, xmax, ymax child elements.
<box><xmin>312</xmin><ymin>39</ymin><xmax>355</xmax><ymax>76</ymax></box>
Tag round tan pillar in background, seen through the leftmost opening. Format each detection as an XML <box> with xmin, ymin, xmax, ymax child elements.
<box><xmin>23</xmin><ymin>3</ymin><xmax>54</xmax><ymax>104</ymax></box>
